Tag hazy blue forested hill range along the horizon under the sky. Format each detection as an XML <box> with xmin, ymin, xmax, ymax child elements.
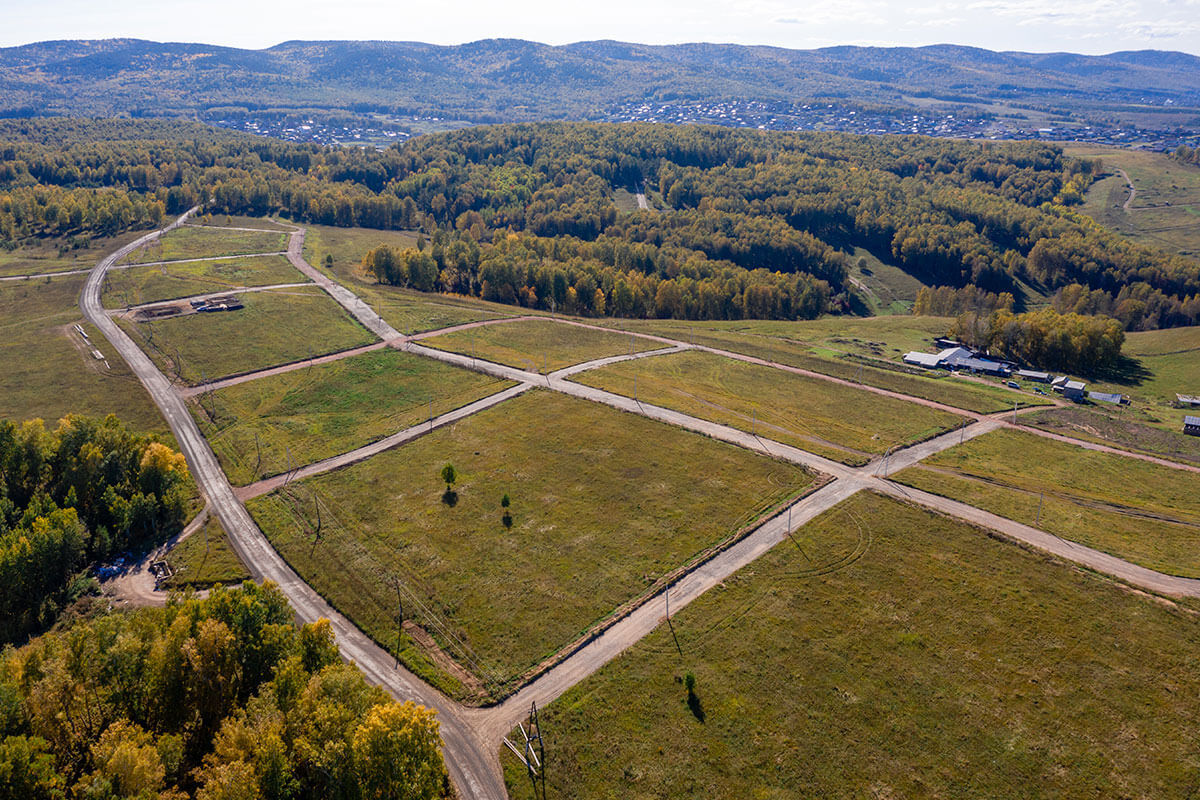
<box><xmin>7</xmin><ymin>40</ymin><xmax>1200</xmax><ymax>124</ymax></box>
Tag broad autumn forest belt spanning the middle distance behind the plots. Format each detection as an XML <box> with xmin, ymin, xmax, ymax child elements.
<box><xmin>7</xmin><ymin>120</ymin><xmax>1200</xmax><ymax>330</ymax></box>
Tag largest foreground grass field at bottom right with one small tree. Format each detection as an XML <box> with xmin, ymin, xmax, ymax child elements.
<box><xmin>500</xmin><ymin>493</ymin><xmax>1200</xmax><ymax>800</ymax></box>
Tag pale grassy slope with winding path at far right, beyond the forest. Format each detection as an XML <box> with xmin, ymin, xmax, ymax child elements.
<box><xmin>1067</xmin><ymin>145</ymin><xmax>1200</xmax><ymax>255</ymax></box>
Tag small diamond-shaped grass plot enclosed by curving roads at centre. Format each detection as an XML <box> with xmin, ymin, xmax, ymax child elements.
<box><xmin>421</xmin><ymin>319</ymin><xmax>667</xmax><ymax>374</ymax></box>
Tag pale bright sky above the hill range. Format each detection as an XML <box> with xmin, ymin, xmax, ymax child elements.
<box><xmin>0</xmin><ymin>0</ymin><xmax>1200</xmax><ymax>55</ymax></box>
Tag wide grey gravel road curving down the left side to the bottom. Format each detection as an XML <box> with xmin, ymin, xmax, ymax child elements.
<box><xmin>79</xmin><ymin>209</ymin><xmax>508</xmax><ymax>800</ymax></box>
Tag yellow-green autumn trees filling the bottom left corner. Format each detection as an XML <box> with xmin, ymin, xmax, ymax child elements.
<box><xmin>0</xmin><ymin>583</ymin><xmax>450</xmax><ymax>800</ymax></box>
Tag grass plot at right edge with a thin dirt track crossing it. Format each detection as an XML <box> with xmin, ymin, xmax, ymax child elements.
<box><xmin>893</xmin><ymin>431</ymin><xmax>1200</xmax><ymax>577</ymax></box>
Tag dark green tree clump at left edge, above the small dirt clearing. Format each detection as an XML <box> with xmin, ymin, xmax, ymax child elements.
<box><xmin>0</xmin><ymin>416</ymin><xmax>190</xmax><ymax>643</ymax></box>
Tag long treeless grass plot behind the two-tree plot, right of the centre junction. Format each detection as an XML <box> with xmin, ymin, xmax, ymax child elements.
<box><xmin>572</xmin><ymin>350</ymin><xmax>966</xmax><ymax>465</ymax></box>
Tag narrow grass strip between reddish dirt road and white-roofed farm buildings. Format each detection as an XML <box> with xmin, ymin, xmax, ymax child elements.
<box><xmin>604</xmin><ymin>317</ymin><xmax>1036</xmax><ymax>414</ymax></box>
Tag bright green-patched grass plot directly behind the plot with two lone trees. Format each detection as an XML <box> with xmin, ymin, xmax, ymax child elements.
<box><xmin>192</xmin><ymin>349</ymin><xmax>512</xmax><ymax>483</ymax></box>
